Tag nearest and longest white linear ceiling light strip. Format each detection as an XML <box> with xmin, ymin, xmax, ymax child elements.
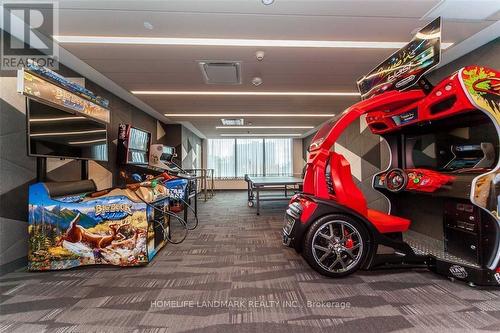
<box><xmin>53</xmin><ymin>35</ymin><xmax>453</xmax><ymax>49</ymax></box>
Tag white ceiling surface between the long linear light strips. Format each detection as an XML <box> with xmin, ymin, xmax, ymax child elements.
<box><xmin>44</xmin><ymin>0</ymin><xmax>500</xmax><ymax>137</ymax></box>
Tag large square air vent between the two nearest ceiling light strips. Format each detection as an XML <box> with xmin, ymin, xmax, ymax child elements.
<box><xmin>199</xmin><ymin>61</ymin><xmax>241</xmax><ymax>84</ymax></box>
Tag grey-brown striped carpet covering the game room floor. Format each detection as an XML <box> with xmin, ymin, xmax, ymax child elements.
<box><xmin>0</xmin><ymin>192</ymin><xmax>500</xmax><ymax>333</ymax></box>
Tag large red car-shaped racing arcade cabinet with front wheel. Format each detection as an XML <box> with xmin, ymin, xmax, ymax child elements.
<box><xmin>283</xmin><ymin>19</ymin><xmax>500</xmax><ymax>285</ymax></box>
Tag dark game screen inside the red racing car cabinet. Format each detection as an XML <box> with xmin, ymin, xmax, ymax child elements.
<box><xmin>405</xmin><ymin>113</ymin><xmax>499</xmax><ymax>172</ymax></box>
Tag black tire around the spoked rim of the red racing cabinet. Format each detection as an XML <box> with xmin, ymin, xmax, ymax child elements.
<box><xmin>302</xmin><ymin>214</ymin><xmax>370</xmax><ymax>278</ymax></box>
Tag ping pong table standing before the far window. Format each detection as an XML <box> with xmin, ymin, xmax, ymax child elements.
<box><xmin>245</xmin><ymin>175</ymin><xmax>303</xmax><ymax>215</ymax></box>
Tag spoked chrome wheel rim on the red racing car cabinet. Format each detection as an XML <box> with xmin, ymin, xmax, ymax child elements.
<box><xmin>312</xmin><ymin>220</ymin><xmax>364</xmax><ymax>273</ymax></box>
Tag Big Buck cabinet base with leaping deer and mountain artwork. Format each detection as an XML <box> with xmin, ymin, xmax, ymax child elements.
<box><xmin>28</xmin><ymin>183</ymin><xmax>154</xmax><ymax>270</ymax></box>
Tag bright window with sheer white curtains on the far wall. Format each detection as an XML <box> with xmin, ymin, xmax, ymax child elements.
<box><xmin>207</xmin><ymin>138</ymin><xmax>293</xmax><ymax>178</ymax></box>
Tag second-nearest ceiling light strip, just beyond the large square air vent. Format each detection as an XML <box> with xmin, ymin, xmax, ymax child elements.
<box><xmin>130</xmin><ymin>90</ymin><xmax>359</xmax><ymax>96</ymax></box>
